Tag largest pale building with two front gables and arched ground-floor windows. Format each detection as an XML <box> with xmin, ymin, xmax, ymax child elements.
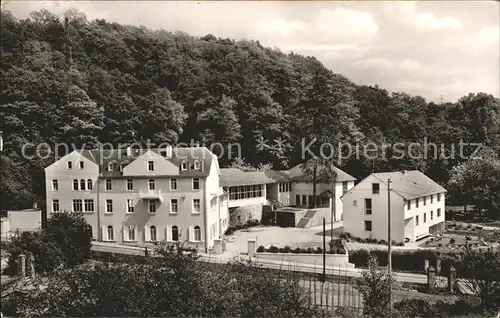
<box><xmin>45</xmin><ymin>147</ymin><xmax>229</xmax><ymax>251</ymax></box>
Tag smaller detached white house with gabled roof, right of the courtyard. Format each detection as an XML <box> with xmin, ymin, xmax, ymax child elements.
<box><xmin>342</xmin><ymin>170</ymin><xmax>446</xmax><ymax>242</ymax></box>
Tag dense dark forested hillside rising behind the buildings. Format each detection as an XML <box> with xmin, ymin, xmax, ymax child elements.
<box><xmin>0</xmin><ymin>11</ymin><xmax>500</xmax><ymax>215</ymax></box>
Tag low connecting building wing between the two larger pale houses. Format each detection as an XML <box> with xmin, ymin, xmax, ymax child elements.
<box><xmin>221</xmin><ymin>165</ymin><xmax>356</xmax><ymax>224</ymax></box>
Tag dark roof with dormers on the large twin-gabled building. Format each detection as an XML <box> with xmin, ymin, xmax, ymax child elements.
<box><xmin>80</xmin><ymin>147</ymin><xmax>213</xmax><ymax>178</ymax></box>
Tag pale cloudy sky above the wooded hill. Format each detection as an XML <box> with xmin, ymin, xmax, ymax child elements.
<box><xmin>2</xmin><ymin>0</ymin><xmax>500</xmax><ymax>102</ymax></box>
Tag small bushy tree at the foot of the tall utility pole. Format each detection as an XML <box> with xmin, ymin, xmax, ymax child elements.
<box><xmin>356</xmin><ymin>255</ymin><xmax>394</xmax><ymax>317</ymax></box>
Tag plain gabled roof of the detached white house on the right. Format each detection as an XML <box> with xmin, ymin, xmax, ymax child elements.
<box><xmin>372</xmin><ymin>170</ymin><xmax>446</xmax><ymax>200</ymax></box>
